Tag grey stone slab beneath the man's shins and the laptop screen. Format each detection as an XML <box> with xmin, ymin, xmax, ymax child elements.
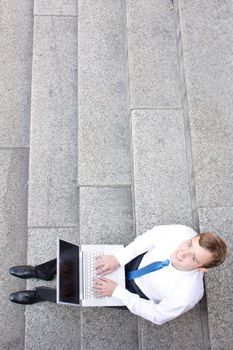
<box><xmin>25</xmin><ymin>227</ymin><xmax>80</xmax><ymax>350</ymax></box>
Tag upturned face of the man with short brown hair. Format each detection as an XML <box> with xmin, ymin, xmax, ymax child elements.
<box><xmin>170</xmin><ymin>236</ymin><xmax>212</xmax><ymax>272</ymax></box>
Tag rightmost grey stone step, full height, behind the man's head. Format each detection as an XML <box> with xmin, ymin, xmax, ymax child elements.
<box><xmin>175</xmin><ymin>0</ymin><xmax>233</xmax><ymax>349</ymax></box>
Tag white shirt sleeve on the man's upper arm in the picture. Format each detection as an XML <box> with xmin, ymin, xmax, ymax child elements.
<box><xmin>114</xmin><ymin>225</ymin><xmax>167</xmax><ymax>266</ymax></box>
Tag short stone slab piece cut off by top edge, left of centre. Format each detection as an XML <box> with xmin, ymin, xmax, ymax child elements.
<box><xmin>34</xmin><ymin>0</ymin><xmax>78</xmax><ymax>16</ymax></box>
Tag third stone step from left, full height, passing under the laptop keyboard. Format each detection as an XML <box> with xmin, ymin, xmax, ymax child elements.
<box><xmin>78</xmin><ymin>0</ymin><xmax>138</xmax><ymax>350</ymax></box>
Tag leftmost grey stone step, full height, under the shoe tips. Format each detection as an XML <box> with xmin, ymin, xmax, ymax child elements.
<box><xmin>0</xmin><ymin>0</ymin><xmax>33</xmax><ymax>350</ymax></box>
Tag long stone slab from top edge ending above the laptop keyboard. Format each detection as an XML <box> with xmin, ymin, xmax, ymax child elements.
<box><xmin>78</xmin><ymin>0</ymin><xmax>131</xmax><ymax>186</ymax></box>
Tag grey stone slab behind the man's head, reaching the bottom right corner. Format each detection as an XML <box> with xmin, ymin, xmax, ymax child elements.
<box><xmin>198</xmin><ymin>208</ymin><xmax>233</xmax><ymax>350</ymax></box>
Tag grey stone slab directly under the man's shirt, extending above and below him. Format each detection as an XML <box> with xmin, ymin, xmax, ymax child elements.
<box><xmin>132</xmin><ymin>110</ymin><xmax>203</xmax><ymax>350</ymax></box>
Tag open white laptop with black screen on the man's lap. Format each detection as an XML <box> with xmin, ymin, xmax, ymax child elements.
<box><xmin>57</xmin><ymin>238</ymin><xmax>125</xmax><ymax>307</ymax></box>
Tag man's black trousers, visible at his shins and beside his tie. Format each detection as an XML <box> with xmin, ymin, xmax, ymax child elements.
<box><xmin>36</xmin><ymin>253</ymin><xmax>148</xmax><ymax>303</ymax></box>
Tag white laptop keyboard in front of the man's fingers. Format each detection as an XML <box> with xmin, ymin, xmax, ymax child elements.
<box><xmin>84</xmin><ymin>251</ymin><xmax>103</xmax><ymax>299</ymax></box>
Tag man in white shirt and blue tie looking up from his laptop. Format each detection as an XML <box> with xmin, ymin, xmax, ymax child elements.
<box><xmin>10</xmin><ymin>225</ymin><xmax>226</xmax><ymax>325</ymax></box>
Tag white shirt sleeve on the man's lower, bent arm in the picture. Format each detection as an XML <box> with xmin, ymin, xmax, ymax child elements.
<box><xmin>112</xmin><ymin>285</ymin><xmax>194</xmax><ymax>325</ymax></box>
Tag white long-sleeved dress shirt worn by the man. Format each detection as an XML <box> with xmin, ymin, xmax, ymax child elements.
<box><xmin>112</xmin><ymin>225</ymin><xmax>204</xmax><ymax>325</ymax></box>
